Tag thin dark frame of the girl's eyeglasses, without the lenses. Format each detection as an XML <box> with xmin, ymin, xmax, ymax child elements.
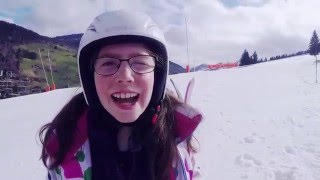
<box><xmin>93</xmin><ymin>54</ymin><xmax>159</xmax><ymax>76</ymax></box>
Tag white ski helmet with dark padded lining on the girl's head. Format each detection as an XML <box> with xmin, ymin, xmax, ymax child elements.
<box><xmin>78</xmin><ymin>10</ymin><xmax>169</xmax><ymax>106</ymax></box>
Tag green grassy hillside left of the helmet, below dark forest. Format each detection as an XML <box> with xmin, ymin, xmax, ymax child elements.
<box><xmin>18</xmin><ymin>43</ymin><xmax>79</xmax><ymax>88</ymax></box>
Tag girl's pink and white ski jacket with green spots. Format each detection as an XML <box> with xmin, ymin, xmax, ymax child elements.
<box><xmin>46</xmin><ymin>104</ymin><xmax>202</xmax><ymax>180</ymax></box>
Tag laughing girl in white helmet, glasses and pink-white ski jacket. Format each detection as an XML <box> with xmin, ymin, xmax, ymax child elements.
<box><xmin>39</xmin><ymin>10</ymin><xmax>202</xmax><ymax>180</ymax></box>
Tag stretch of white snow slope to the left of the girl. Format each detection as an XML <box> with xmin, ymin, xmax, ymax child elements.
<box><xmin>0</xmin><ymin>88</ymin><xmax>79</xmax><ymax>180</ymax></box>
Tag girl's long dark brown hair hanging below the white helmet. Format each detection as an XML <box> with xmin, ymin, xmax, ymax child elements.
<box><xmin>39</xmin><ymin>93</ymin><xmax>194</xmax><ymax>180</ymax></box>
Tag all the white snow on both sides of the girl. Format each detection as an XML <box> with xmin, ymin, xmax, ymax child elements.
<box><xmin>0</xmin><ymin>56</ymin><xmax>320</xmax><ymax>180</ymax></box>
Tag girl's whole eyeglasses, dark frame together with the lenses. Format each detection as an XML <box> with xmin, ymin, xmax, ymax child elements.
<box><xmin>94</xmin><ymin>55</ymin><xmax>156</xmax><ymax>76</ymax></box>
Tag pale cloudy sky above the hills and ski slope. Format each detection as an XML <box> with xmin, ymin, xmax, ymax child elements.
<box><xmin>0</xmin><ymin>0</ymin><xmax>320</xmax><ymax>65</ymax></box>
